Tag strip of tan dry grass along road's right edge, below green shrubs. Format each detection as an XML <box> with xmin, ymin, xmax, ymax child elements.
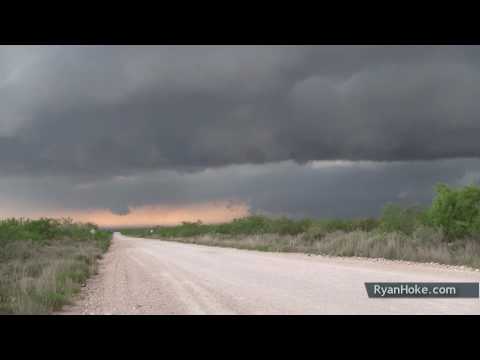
<box><xmin>145</xmin><ymin>227</ymin><xmax>480</xmax><ymax>268</ymax></box>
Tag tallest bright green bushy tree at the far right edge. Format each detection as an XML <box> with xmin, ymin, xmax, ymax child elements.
<box><xmin>429</xmin><ymin>184</ymin><xmax>480</xmax><ymax>239</ymax></box>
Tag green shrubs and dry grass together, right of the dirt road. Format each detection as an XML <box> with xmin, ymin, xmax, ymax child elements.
<box><xmin>122</xmin><ymin>184</ymin><xmax>480</xmax><ymax>268</ymax></box>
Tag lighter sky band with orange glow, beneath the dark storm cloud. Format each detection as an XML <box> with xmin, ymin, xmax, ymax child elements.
<box><xmin>0</xmin><ymin>159</ymin><xmax>480</xmax><ymax>223</ymax></box>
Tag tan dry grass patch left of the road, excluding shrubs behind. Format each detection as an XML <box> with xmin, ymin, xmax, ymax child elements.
<box><xmin>0</xmin><ymin>240</ymin><xmax>109</xmax><ymax>314</ymax></box>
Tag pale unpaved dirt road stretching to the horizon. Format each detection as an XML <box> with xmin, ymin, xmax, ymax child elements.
<box><xmin>63</xmin><ymin>233</ymin><xmax>480</xmax><ymax>314</ymax></box>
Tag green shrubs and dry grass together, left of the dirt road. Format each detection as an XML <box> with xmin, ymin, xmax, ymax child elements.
<box><xmin>0</xmin><ymin>219</ymin><xmax>111</xmax><ymax>314</ymax></box>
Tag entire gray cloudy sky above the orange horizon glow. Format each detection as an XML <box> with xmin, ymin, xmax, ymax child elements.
<box><xmin>0</xmin><ymin>46</ymin><xmax>480</xmax><ymax>225</ymax></box>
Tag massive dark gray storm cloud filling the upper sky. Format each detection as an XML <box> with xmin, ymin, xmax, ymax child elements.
<box><xmin>0</xmin><ymin>46</ymin><xmax>480</xmax><ymax>177</ymax></box>
